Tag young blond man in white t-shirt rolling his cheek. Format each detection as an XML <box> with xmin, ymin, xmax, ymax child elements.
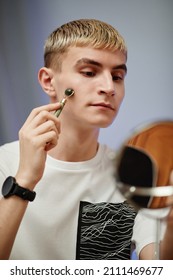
<box><xmin>0</xmin><ymin>20</ymin><xmax>172</xmax><ymax>259</ymax></box>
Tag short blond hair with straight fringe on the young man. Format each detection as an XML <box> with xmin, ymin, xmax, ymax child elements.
<box><xmin>44</xmin><ymin>19</ymin><xmax>127</xmax><ymax>68</ymax></box>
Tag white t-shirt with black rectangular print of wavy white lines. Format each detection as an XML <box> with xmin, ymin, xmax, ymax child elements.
<box><xmin>0</xmin><ymin>141</ymin><xmax>159</xmax><ymax>260</ymax></box>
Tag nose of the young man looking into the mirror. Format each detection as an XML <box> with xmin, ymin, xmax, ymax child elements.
<box><xmin>100</xmin><ymin>74</ymin><xmax>115</xmax><ymax>96</ymax></box>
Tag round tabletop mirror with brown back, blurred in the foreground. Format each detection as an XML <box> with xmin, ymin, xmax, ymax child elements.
<box><xmin>116</xmin><ymin>120</ymin><xmax>173</xmax><ymax>209</ymax></box>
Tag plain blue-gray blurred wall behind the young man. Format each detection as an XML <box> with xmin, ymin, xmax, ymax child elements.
<box><xmin>0</xmin><ymin>0</ymin><xmax>173</xmax><ymax>148</ymax></box>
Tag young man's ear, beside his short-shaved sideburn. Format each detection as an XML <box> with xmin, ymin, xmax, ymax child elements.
<box><xmin>38</xmin><ymin>67</ymin><xmax>56</xmax><ymax>99</ymax></box>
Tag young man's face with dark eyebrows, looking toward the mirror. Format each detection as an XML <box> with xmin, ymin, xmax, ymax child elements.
<box><xmin>53</xmin><ymin>47</ymin><xmax>126</xmax><ymax>128</ymax></box>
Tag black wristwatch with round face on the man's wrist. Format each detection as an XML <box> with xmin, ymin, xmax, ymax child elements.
<box><xmin>2</xmin><ymin>176</ymin><xmax>36</xmax><ymax>201</ymax></box>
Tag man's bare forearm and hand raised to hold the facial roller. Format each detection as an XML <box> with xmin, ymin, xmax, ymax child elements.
<box><xmin>0</xmin><ymin>103</ymin><xmax>60</xmax><ymax>259</ymax></box>
